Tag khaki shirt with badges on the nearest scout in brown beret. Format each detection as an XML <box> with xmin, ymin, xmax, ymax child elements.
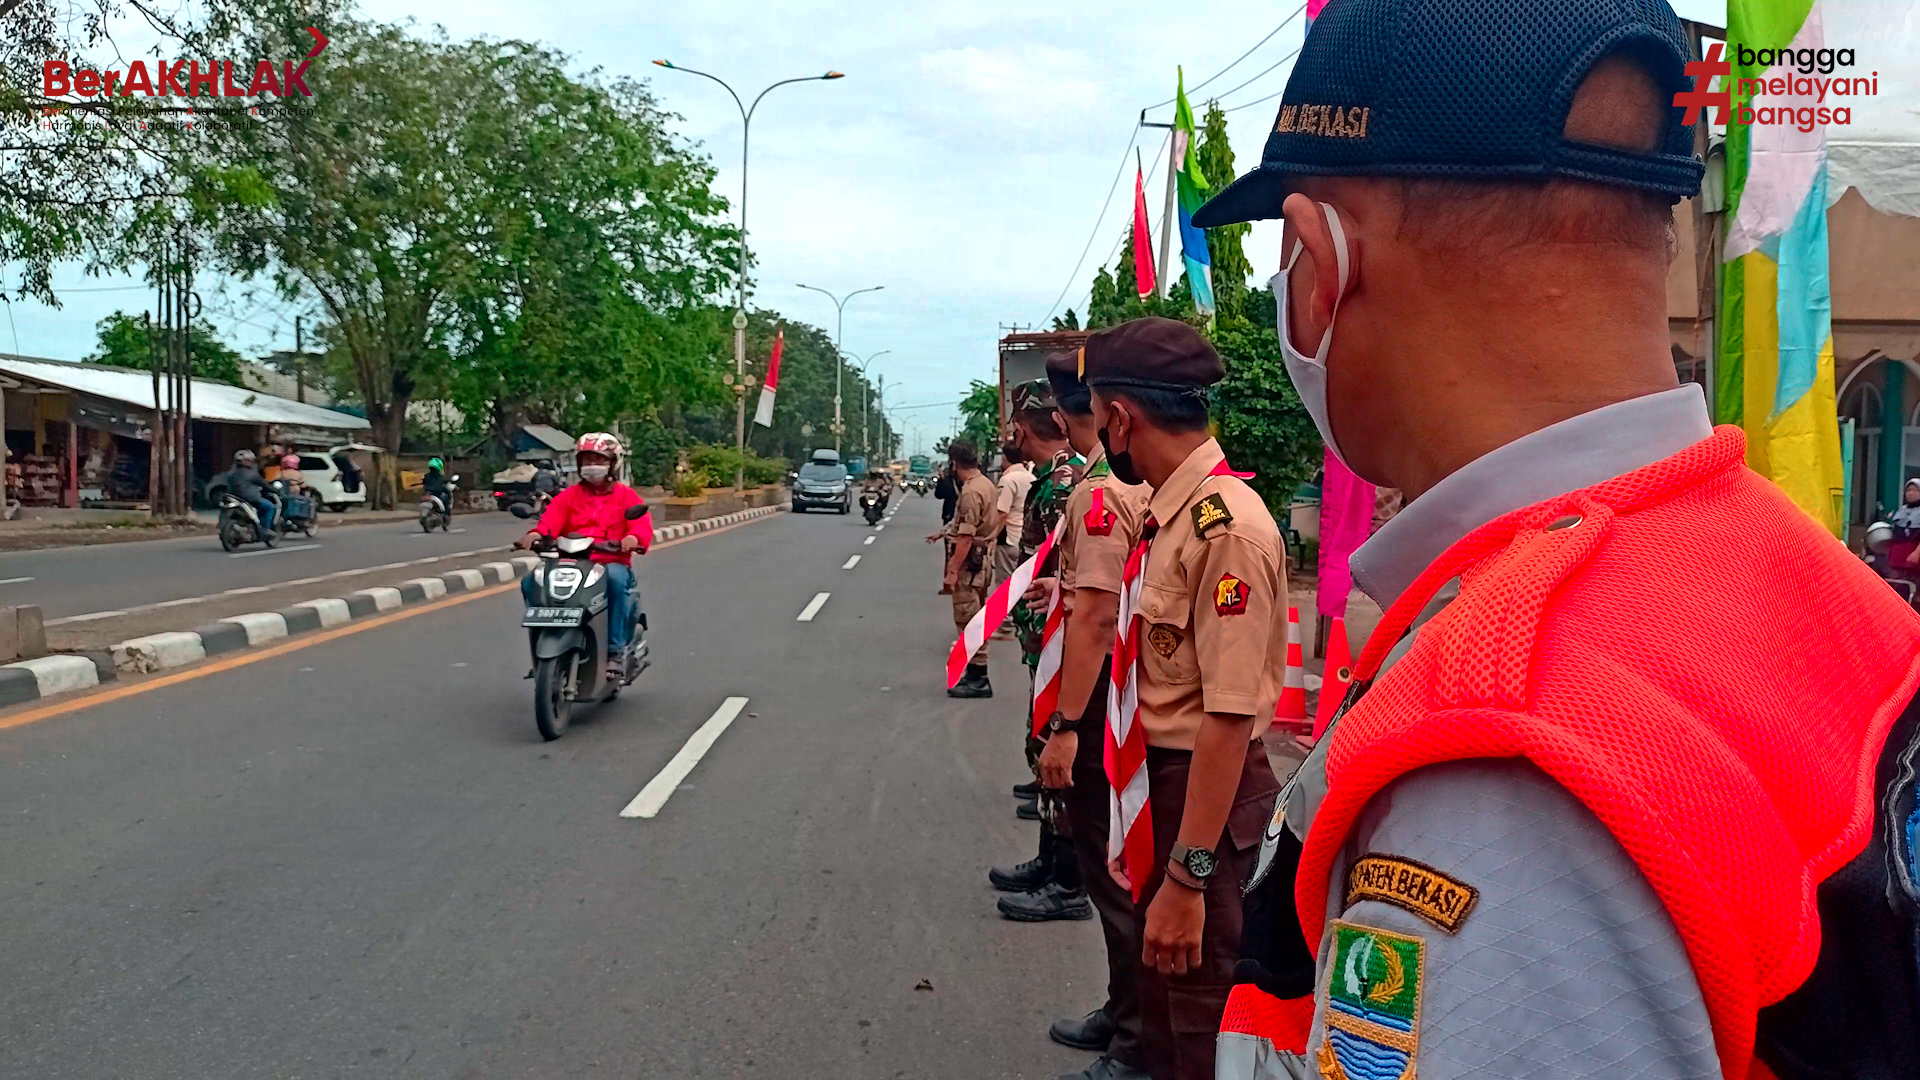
<box><xmin>1139</xmin><ymin>438</ymin><xmax>1286</xmax><ymax>749</ymax></box>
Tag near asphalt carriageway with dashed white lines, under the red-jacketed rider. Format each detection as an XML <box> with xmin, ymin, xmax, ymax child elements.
<box><xmin>0</xmin><ymin>498</ymin><xmax>1102</xmax><ymax>1080</ymax></box>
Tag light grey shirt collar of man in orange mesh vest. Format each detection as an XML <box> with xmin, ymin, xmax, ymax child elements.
<box><xmin>1348</xmin><ymin>382</ymin><xmax>1713</xmax><ymax>607</ymax></box>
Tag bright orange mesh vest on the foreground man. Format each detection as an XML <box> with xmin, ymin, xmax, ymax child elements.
<box><xmin>1294</xmin><ymin>427</ymin><xmax>1920</xmax><ymax>1080</ymax></box>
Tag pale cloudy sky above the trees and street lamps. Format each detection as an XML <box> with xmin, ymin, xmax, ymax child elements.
<box><xmin>0</xmin><ymin>0</ymin><xmax>1726</xmax><ymax>453</ymax></box>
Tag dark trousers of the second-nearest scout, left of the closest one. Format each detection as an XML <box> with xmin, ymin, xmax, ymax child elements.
<box><xmin>1066</xmin><ymin>665</ymin><xmax>1146</xmax><ymax>1068</ymax></box>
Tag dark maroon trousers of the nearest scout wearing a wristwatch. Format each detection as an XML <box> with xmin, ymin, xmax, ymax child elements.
<box><xmin>1135</xmin><ymin>740</ymin><xmax>1281</xmax><ymax>1080</ymax></box>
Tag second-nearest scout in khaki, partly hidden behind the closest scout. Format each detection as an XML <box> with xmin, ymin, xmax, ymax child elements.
<box><xmin>1000</xmin><ymin>354</ymin><xmax>1152</xmax><ymax>1080</ymax></box>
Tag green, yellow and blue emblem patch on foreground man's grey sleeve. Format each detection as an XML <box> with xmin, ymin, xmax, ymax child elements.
<box><xmin>1317</xmin><ymin>920</ymin><xmax>1427</xmax><ymax>1080</ymax></box>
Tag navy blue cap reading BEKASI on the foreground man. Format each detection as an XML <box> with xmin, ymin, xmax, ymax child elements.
<box><xmin>1194</xmin><ymin>0</ymin><xmax>1705</xmax><ymax>229</ymax></box>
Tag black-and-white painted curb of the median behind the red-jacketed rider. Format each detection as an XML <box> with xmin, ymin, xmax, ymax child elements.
<box><xmin>0</xmin><ymin>503</ymin><xmax>787</xmax><ymax>707</ymax></box>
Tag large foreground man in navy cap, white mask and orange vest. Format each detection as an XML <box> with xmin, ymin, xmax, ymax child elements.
<box><xmin>1194</xmin><ymin>0</ymin><xmax>1920</xmax><ymax>1080</ymax></box>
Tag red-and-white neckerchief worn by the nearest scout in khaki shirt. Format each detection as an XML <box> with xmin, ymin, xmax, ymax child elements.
<box><xmin>1106</xmin><ymin>461</ymin><xmax>1254</xmax><ymax>899</ymax></box>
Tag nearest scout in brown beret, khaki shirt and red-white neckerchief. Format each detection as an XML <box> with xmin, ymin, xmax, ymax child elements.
<box><xmin>1083</xmin><ymin>319</ymin><xmax>1286</xmax><ymax>1080</ymax></box>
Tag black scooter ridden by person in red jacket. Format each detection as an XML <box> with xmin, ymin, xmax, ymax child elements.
<box><xmin>511</xmin><ymin>503</ymin><xmax>651</xmax><ymax>742</ymax></box>
